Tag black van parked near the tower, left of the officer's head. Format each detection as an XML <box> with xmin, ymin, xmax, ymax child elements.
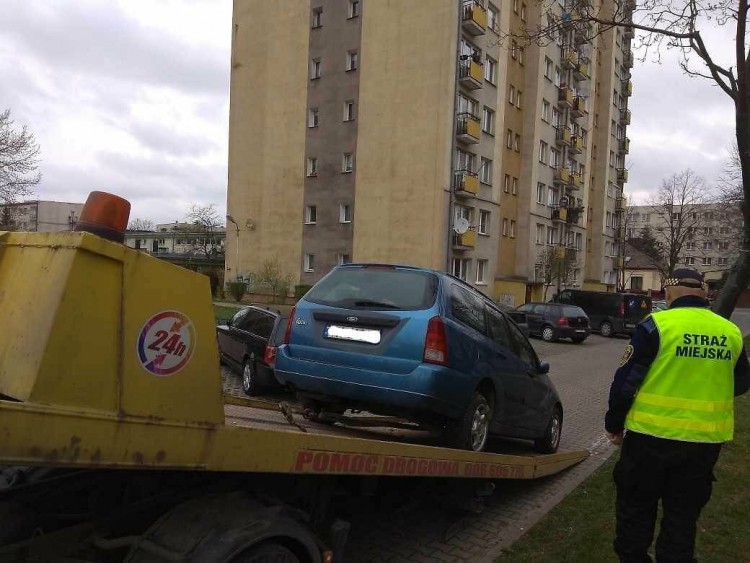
<box><xmin>555</xmin><ymin>289</ymin><xmax>651</xmax><ymax>336</ymax></box>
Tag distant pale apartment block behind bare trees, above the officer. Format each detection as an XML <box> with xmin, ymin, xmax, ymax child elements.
<box><xmin>625</xmin><ymin>203</ymin><xmax>742</xmax><ymax>288</ymax></box>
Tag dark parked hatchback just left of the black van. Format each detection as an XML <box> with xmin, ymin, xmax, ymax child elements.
<box><xmin>518</xmin><ymin>303</ymin><xmax>591</xmax><ymax>344</ymax></box>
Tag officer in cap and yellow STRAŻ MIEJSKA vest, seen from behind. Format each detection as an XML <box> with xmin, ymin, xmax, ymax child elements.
<box><xmin>605</xmin><ymin>268</ymin><xmax>750</xmax><ymax>562</ymax></box>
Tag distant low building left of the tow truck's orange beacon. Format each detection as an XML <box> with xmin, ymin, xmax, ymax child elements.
<box><xmin>0</xmin><ymin>200</ymin><xmax>83</xmax><ymax>233</ymax></box>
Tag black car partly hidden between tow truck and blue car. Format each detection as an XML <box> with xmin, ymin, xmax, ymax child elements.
<box><xmin>216</xmin><ymin>305</ymin><xmax>286</xmax><ymax>395</ymax></box>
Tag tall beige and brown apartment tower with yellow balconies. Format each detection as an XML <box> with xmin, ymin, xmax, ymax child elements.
<box><xmin>226</xmin><ymin>0</ymin><xmax>634</xmax><ymax>304</ymax></box>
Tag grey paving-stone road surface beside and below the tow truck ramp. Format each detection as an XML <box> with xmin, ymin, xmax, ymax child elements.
<box><xmin>224</xmin><ymin>335</ymin><xmax>627</xmax><ymax>563</ymax></box>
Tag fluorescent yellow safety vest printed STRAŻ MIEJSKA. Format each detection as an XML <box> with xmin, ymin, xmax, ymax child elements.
<box><xmin>625</xmin><ymin>307</ymin><xmax>743</xmax><ymax>443</ymax></box>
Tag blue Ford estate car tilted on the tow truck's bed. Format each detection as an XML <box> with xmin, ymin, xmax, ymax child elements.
<box><xmin>276</xmin><ymin>264</ymin><xmax>563</xmax><ymax>452</ymax></box>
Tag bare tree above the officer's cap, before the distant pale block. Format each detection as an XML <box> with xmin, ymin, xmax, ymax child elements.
<box><xmin>648</xmin><ymin>169</ymin><xmax>709</xmax><ymax>277</ymax></box>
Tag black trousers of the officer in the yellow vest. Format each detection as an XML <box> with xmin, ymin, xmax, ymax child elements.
<box><xmin>614</xmin><ymin>432</ymin><xmax>721</xmax><ymax>563</ymax></box>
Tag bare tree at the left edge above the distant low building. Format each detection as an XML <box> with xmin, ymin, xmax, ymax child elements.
<box><xmin>0</xmin><ymin>109</ymin><xmax>42</xmax><ymax>204</ymax></box>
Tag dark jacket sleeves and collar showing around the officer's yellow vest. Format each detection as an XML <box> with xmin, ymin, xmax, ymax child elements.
<box><xmin>604</xmin><ymin>295</ymin><xmax>750</xmax><ymax>434</ymax></box>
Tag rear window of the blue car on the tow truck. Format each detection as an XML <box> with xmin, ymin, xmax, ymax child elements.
<box><xmin>305</xmin><ymin>267</ymin><xmax>438</xmax><ymax>311</ymax></box>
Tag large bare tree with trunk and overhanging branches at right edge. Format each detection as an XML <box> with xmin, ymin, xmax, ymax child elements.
<box><xmin>500</xmin><ymin>0</ymin><xmax>750</xmax><ymax>317</ymax></box>
